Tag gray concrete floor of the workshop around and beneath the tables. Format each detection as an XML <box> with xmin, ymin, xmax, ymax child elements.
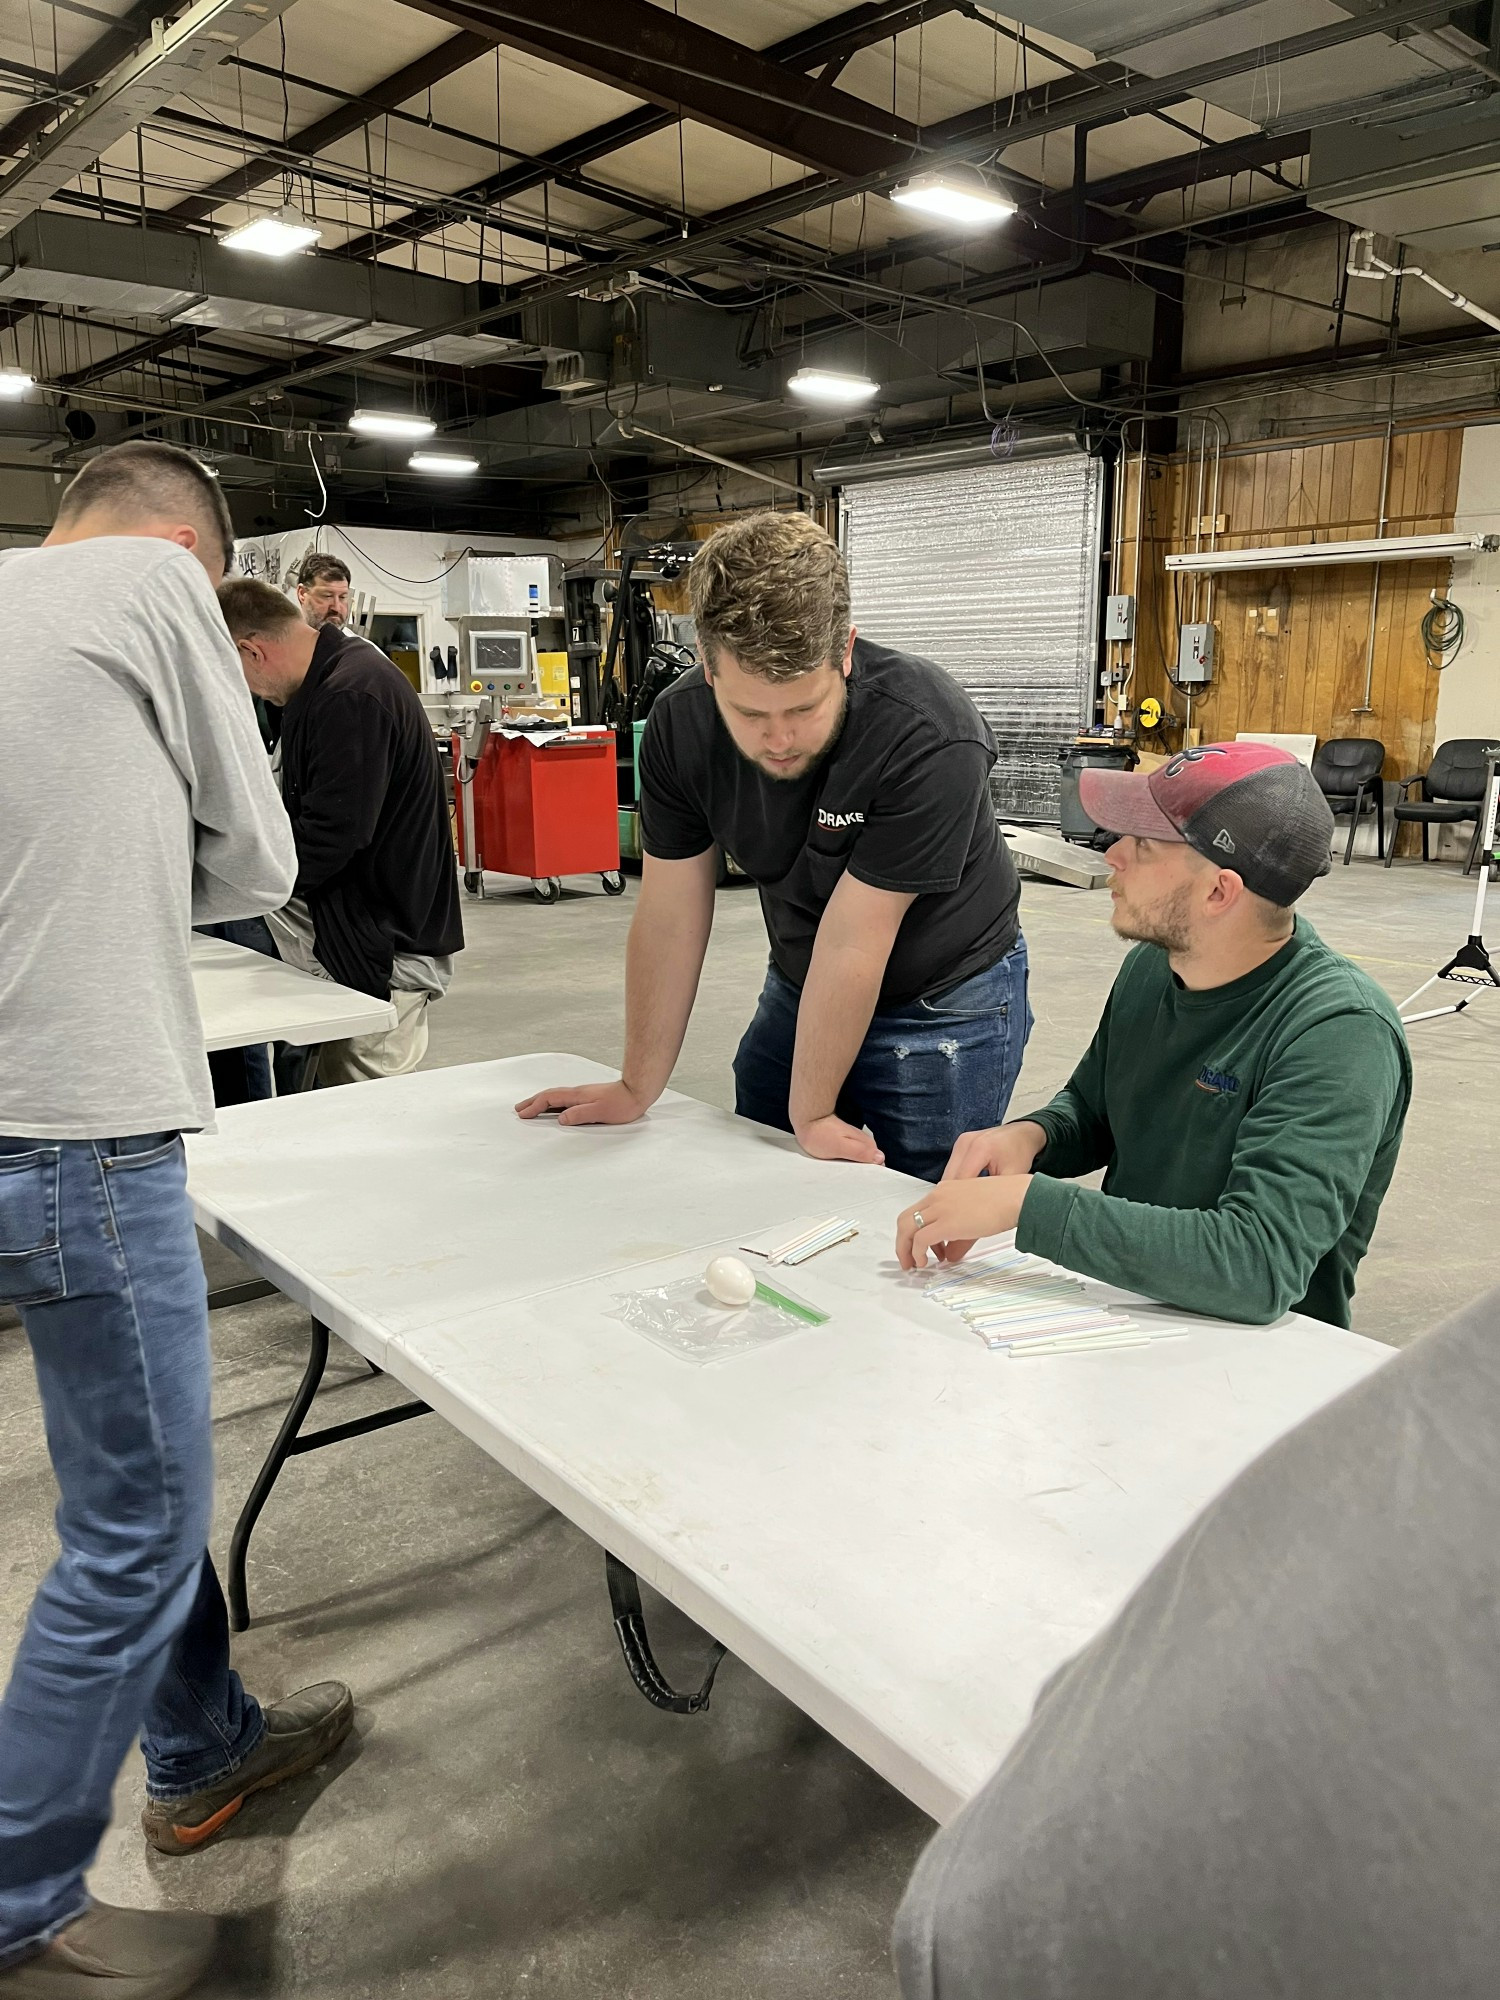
<box><xmin>0</xmin><ymin>862</ymin><xmax>1500</xmax><ymax>2000</ymax></box>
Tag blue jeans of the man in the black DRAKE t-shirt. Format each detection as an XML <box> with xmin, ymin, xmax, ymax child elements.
<box><xmin>734</xmin><ymin>936</ymin><xmax>1032</xmax><ymax>1180</ymax></box>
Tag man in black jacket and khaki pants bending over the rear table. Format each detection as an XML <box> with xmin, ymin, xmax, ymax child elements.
<box><xmin>218</xmin><ymin>576</ymin><xmax>464</xmax><ymax>1084</ymax></box>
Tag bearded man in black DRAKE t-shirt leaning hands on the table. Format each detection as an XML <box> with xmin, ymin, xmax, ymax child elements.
<box><xmin>518</xmin><ymin>514</ymin><xmax>1030</xmax><ymax>1180</ymax></box>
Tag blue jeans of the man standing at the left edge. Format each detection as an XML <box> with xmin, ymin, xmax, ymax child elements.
<box><xmin>0</xmin><ymin>1132</ymin><xmax>266</xmax><ymax>1966</ymax></box>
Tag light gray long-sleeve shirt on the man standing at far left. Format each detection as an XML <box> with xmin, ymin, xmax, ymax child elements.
<box><xmin>0</xmin><ymin>536</ymin><xmax>296</xmax><ymax>1138</ymax></box>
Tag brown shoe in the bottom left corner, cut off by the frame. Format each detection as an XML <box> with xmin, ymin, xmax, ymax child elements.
<box><xmin>0</xmin><ymin>1902</ymin><xmax>218</xmax><ymax>2000</ymax></box>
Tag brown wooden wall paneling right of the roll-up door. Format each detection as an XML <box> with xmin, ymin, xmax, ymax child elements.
<box><xmin>1116</xmin><ymin>430</ymin><xmax>1462</xmax><ymax>812</ymax></box>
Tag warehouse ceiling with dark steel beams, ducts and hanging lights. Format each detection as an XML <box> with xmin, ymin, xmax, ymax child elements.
<box><xmin>0</xmin><ymin>0</ymin><xmax>1500</xmax><ymax>526</ymax></box>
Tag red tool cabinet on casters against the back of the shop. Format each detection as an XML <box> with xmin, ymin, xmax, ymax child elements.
<box><xmin>454</xmin><ymin>730</ymin><xmax>624</xmax><ymax>902</ymax></box>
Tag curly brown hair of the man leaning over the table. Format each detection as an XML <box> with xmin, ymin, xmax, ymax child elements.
<box><xmin>690</xmin><ymin>514</ymin><xmax>850</xmax><ymax>680</ymax></box>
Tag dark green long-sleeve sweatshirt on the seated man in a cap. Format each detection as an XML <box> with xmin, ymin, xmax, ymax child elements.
<box><xmin>1016</xmin><ymin>918</ymin><xmax>1412</xmax><ymax>1326</ymax></box>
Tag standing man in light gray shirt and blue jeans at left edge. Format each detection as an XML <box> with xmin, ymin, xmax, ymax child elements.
<box><xmin>0</xmin><ymin>442</ymin><xmax>352</xmax><ymax>2000</ymax></box>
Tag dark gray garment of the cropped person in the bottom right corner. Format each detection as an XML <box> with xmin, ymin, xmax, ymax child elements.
<box><xmin>896</xmin><ymin>1290</ymin><xmax>1500</xmax><ymax>2000</ymax></box>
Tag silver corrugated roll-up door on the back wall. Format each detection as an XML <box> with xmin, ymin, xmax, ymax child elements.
<box><xmin>842</xmin><ymin>452</ymin><xmax>1102</xmax><ymax>820</ymax></box>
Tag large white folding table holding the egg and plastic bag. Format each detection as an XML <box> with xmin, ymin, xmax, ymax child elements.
<box><xmin>190</xmin><ymin>1056</ymin><xmax>1390</xmax><ymax>1818</ymax></box>
